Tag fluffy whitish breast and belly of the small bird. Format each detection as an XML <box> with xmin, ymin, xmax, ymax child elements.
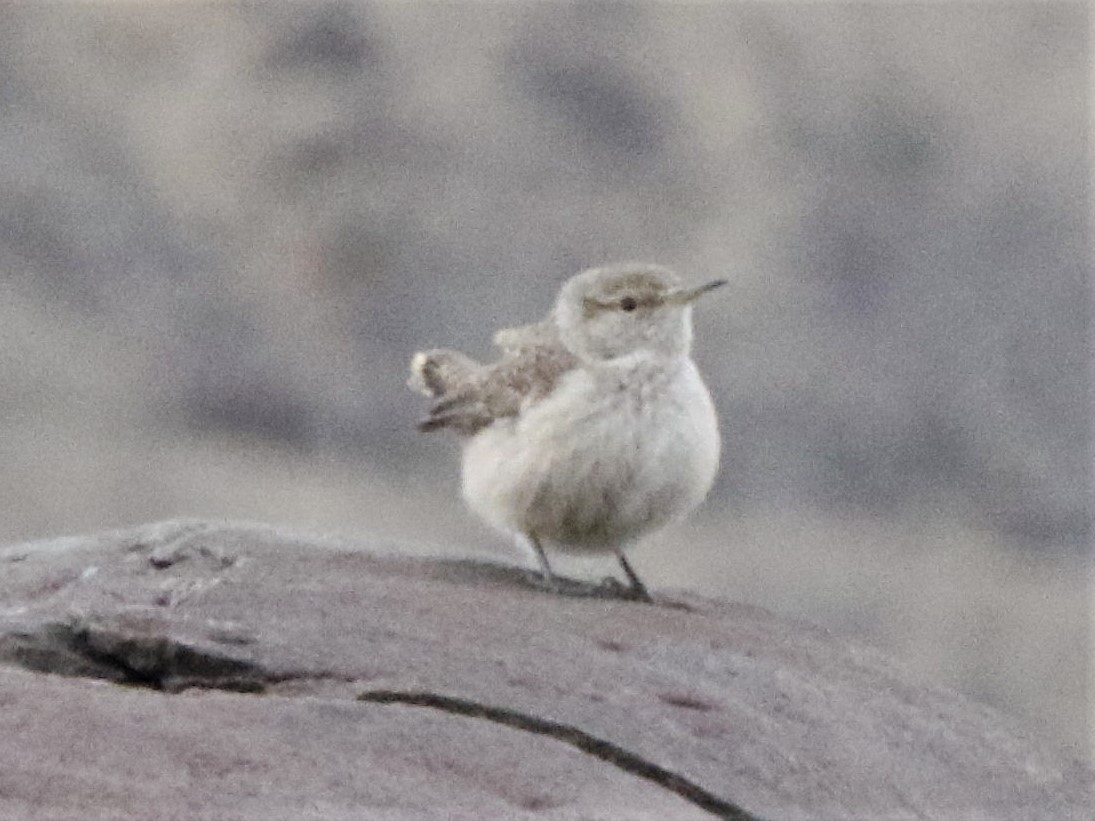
<box><xmin>463</xmin><ymin>356</ymin><xmax>719</xmax><ymax>551</ymax></box>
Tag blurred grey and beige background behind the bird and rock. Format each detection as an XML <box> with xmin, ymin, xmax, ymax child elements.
<box><xmin>0</xmin><ymin>1</ymin><xmax>1093</xmax><ymax>754</ymax></box>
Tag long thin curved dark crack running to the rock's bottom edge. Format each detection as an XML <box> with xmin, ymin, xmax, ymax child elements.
<box><xmin>357</xmin><ymin>690</ymin><xmax>761</xmax><ymax>821</ymax></box>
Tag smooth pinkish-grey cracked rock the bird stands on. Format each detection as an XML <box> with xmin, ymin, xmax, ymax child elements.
<box><xmin>0</xmin><ymin>521</ymin><xmax>1095</xmax><ymax>821</ymax></box>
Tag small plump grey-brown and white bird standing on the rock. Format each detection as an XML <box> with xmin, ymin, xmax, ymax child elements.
<box><xmin>408</xmin><ymin>263</ymin><xmax>726</xmax><ymax>601</ymax></box>
